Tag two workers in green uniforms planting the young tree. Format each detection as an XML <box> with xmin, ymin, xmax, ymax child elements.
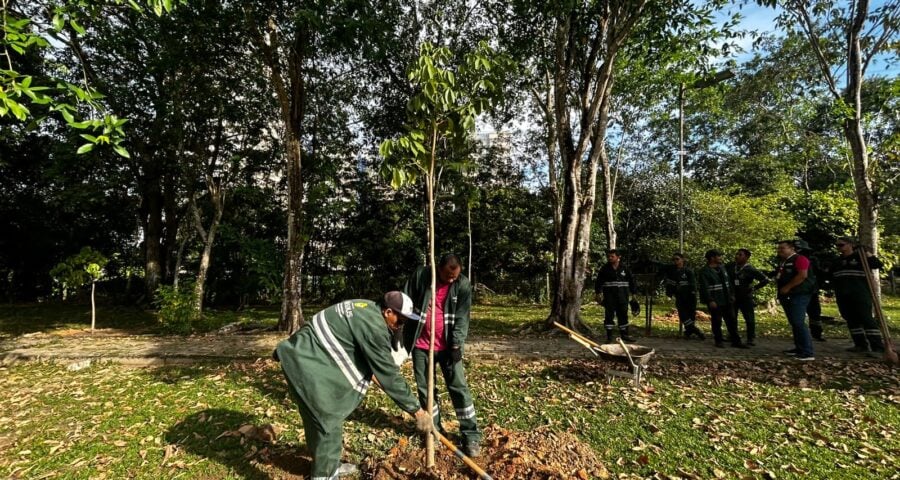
<box><xmin>273</xmin><ymin>254</ymin><xmax>482</xmax><ymax>480</ymax></box>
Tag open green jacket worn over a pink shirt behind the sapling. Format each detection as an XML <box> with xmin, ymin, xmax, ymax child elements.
<box><xmin>403</xmin><ymin>267</ymin><xmax>472</xmax><ymax>352</ymax></box>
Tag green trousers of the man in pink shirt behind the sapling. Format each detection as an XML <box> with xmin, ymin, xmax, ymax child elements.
<box><xmin>412</xmin><ymin>348</ymin><xmax>481</xmax><ymax>445</ymax></box>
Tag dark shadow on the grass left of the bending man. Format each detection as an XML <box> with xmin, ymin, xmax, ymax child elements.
<box><xmin>165</xmin><ymin>408</ymin><xmax>310</xmax><ymax>479</ymax></box>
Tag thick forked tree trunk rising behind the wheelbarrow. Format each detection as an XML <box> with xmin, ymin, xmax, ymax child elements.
<box><xmin>547</xmin><ymin>0</ymin><xmax>646</xmax><ymax>331</ymax></box>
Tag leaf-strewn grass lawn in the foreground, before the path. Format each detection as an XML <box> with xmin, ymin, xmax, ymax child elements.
<box><xmin>0</xmin><ymin>360</ymin><xmax>900</xmax><ymax>479</ymax></box>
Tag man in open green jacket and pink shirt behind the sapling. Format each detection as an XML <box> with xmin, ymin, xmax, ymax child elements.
<box><xmin>403</xmin><ymin>254</ymin><xmax>482</xmax><ymax>457</ymax></box>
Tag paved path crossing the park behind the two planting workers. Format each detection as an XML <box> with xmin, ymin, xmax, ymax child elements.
<box><xmin>0</xmin><ymin>331</ymin><xmax>869</xmax><ymax>366</ymax></box>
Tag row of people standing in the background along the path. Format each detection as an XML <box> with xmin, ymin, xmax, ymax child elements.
<box><xmin>594</xmin><ymin>237</ymin><xmax>884</xmax><ymax>361</ymax></box>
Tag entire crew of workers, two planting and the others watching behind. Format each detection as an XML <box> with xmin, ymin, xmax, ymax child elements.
<box><xmin>273</xmin><ymin>237</ymin><xmax>884</xmax><ymax>480</ymax></box>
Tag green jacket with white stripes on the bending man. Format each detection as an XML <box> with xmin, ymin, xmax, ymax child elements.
<box><xmin>276</xmin><ymin>300</ymin><xmax>419</xmax><ymax>431</ymax></box>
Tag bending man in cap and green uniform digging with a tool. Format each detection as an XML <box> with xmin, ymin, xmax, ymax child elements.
<box><xmin>273</xmin><ymin>291</ymin><xmax>432</xmax><ymax>480</ymax></box>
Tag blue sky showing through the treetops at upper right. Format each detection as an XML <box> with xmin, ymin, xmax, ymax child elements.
<box><xmin>717</xmin><ymin>0</ymin><xmax>900</xmax><ymax>77</ymax></box>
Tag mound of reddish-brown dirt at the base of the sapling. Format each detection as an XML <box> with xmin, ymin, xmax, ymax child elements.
<box><xmin>363</xmin><ymin>425</ymin><xmax>609</xmax><ymax>480</ymax></box>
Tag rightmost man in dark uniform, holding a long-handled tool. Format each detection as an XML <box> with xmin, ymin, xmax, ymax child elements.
<box><xmin>829</xmin><ymin>237</ymin><xmax>884</xmax><ymax>353</ymax></box>
